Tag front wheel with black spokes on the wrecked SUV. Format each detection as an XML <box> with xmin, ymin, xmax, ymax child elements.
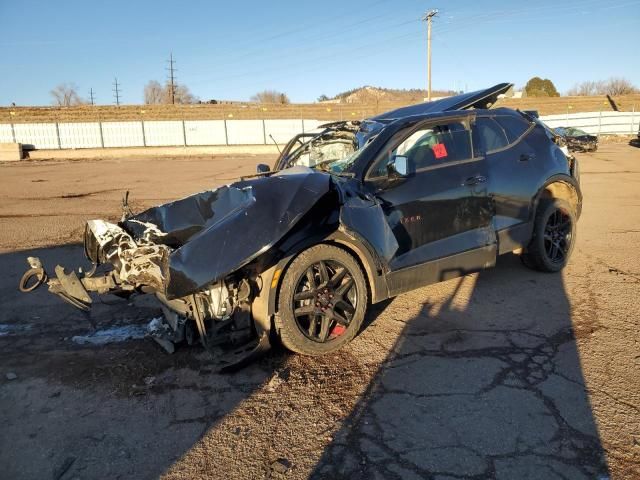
<box><xmin>275</xmin><ymin>245</ymin><xmax>367</xmax><ymax>355</ymax></box>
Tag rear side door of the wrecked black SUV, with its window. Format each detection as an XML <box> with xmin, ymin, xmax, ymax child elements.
<box><xmin>473</xmin><ymin>112</ymin><xmax>544</xmax><ymax>253</ymax></box>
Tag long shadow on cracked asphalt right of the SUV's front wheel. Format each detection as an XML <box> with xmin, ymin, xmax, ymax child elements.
<box><xmin>311</xmin><ymin>254</ymin><xmax>608</xmax><ymax>480</ymax></box>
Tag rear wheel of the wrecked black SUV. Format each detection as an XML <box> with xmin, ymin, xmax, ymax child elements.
<box><xmin>521</xmin><ymin>198</ymin><xmax>577</xmax><ymax>272</ymax></box>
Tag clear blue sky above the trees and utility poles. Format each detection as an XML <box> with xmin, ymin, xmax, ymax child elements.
<box><xmin>0</xmin><ymin>0</ymin><xmax>640</xmax><ymax>105</ymax></box>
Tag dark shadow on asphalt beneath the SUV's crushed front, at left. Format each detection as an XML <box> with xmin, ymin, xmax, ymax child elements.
<box><xmin>0</xmin><ymin>245</ymin><xmax>287</xmax><ymax>479</ymax></box>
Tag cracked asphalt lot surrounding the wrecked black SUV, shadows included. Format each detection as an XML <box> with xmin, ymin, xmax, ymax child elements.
<box><xmin>0</xmin><ymin>144</ymin><xmax>640</xmax><ymax>480</ymax></box>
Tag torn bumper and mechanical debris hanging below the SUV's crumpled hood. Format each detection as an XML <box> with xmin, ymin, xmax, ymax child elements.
<box><xmin>19</xmin><ymin>220</ymin><xmax>271</xmax><ymax>372</ymax></box>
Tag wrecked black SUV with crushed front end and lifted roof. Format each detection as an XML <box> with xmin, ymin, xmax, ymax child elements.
<box><xmin>21</xmin><ymin>84</ymin><xmax>582</xmax><ymax>365</ymax></box>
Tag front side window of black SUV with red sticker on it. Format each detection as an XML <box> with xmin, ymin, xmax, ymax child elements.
<box><xmin>369</xmin><ymin>121</ymin><xmax>473</xmax><ymax>177</ymax></box>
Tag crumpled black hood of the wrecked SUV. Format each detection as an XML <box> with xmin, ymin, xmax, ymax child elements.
<box><xmin>121</xmin><ymin>167</ymin><xmax>330</xmax><ymax>298</ymax></box>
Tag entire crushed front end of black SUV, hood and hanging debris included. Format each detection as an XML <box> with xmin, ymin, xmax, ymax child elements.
<box><xmin>20</xmin><ymin>169</ymin><xmax>329</xmax><ymax>369</ymax></box>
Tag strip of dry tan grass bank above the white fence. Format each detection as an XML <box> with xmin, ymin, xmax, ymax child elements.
<box><xmin>0</xmin><ymin>95</ymin><xmax>640</xmax><ymax>123</ymax></box>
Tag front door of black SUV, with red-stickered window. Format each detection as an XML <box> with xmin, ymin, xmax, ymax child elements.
<box><xmin>365</xmin><ymin>114</ymin><xmax>496</xmax><ymax>295</ymax></box>
